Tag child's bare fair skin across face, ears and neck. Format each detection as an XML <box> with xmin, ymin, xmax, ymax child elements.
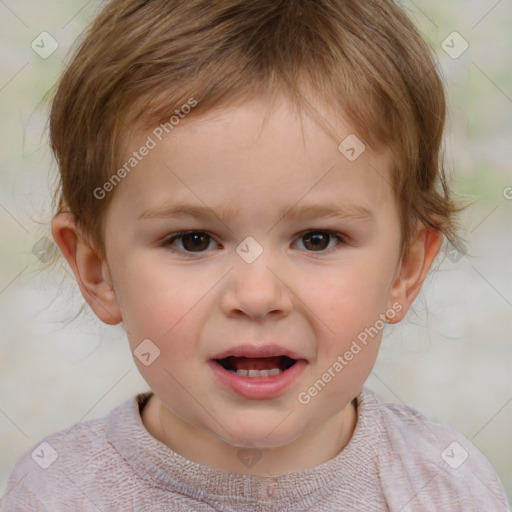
<box><xmin>53</xmin><ymin>92</ymin><xmax>441</xmax><ymax>475</ymax></box>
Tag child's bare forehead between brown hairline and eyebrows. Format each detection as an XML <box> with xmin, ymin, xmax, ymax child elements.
<box><xmin>113</xmin><ymin>97</ymin><xmax>393</xmax><ymax>226</ymax></box>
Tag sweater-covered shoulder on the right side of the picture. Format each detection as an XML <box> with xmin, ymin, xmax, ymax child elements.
<box><xmin>362</xmin><ymin>389</ymin><xmax>509</xmax><ymax>512</ymax></box>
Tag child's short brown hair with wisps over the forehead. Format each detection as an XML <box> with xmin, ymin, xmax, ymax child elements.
<box><xmin>50</xmin><ymin>0</ymin><xmax>458</xmax><ymax>254</ymax></box>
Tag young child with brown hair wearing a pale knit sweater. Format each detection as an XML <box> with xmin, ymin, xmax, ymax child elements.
<box><xmin>1</xmin><ymin>0</ymin><xmax>507</xmax><ymax>512</ymax></box>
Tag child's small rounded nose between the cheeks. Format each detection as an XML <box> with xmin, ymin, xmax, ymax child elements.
<box><xmin>221</xmin><ymin>251</ymin><xmax>292</xmax><ymax>320</ymax></box>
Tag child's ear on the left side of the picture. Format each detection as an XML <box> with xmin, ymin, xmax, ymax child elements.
<box><xmin>52</xmin><ymin>212</ymin><xmax>122</xmax><ymax>325</ymax></box>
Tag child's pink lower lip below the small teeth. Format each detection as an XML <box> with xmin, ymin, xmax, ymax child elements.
<box><xmin>208</xmin><ymin>359</ymin><xmax>307</xmax><ymax>400</ymax></box>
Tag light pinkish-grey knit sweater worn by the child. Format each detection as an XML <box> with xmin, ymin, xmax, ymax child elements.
<box><xmin>0</xmin><ymin>389</ymin><xmax>509</xmax><ymax>512</ymax></box>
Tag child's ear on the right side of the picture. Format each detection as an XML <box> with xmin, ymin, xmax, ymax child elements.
<box><xmin>388</xmin><ymin>222</ymin><xmax>443</xmax><ymax>324</ymax></box>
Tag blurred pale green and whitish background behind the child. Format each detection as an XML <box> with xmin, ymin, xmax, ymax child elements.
<box><xmin>0</xmin><ymin>0</ymin><xmax>512</xmax><ymax>499</ymax></box>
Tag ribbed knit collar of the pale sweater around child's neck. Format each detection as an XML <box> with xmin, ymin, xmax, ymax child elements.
<box><xmin>107</xmin><ymin>388</ymin><xmax>381</xmax><ymax>510</ymax></box>
